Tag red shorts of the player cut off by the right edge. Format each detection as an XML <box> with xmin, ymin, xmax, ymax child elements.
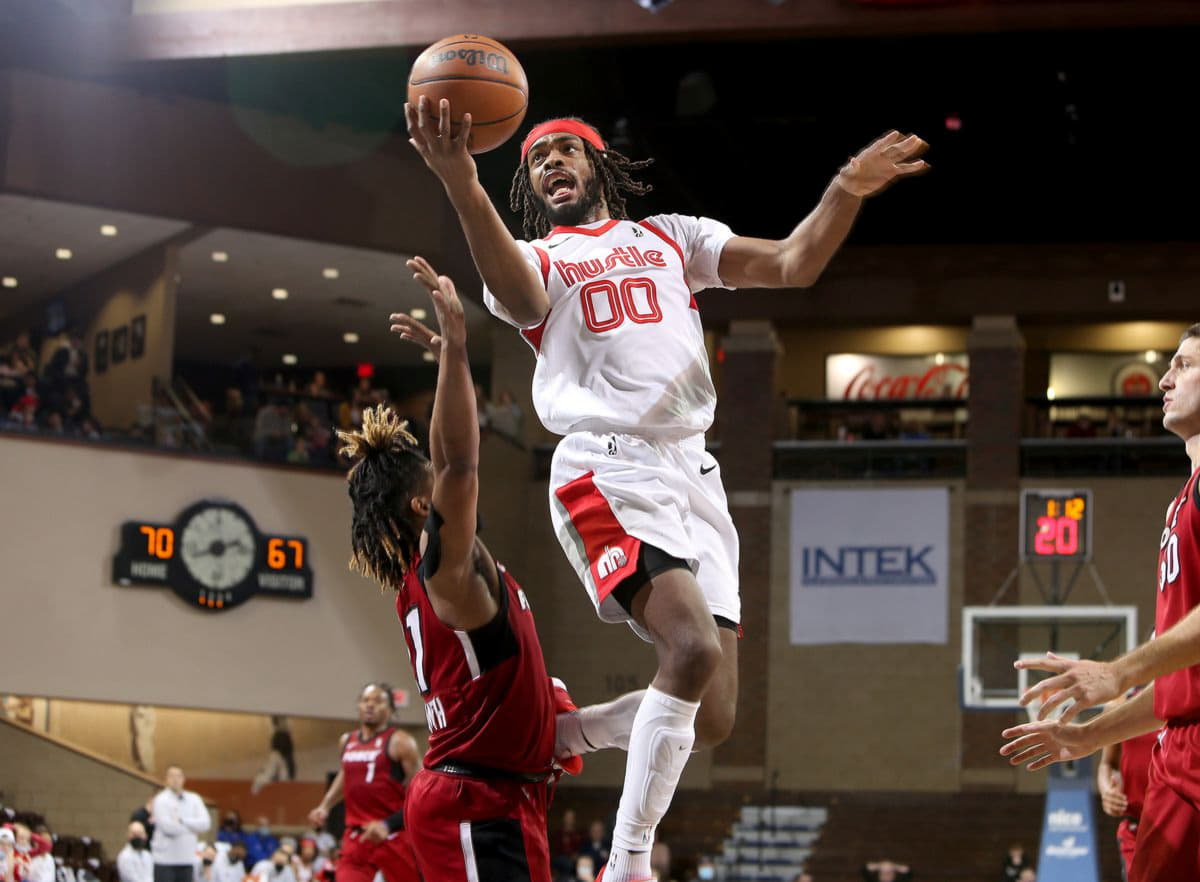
<box><xmin>1129</xmin><ymin>724</ymin><xmax>1200</xmax><ymax>882</ymax></box>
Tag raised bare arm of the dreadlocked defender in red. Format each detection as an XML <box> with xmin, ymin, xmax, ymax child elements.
<box><xmin>408</xmin><ymin>257</ymin><xmax>498</xmax><ymax>629</ymax></box>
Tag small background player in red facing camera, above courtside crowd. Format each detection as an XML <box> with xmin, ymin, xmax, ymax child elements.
<box><xmin>308</xmin><ymin>683</ymin><xmax>421</xmax><ymax>882</ymax></box>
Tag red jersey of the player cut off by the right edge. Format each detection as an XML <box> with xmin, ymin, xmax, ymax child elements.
<box><xmin>1154</xmin><ymin>472</ymin><xmax>1200</xmax><ymax>721</ymax></box>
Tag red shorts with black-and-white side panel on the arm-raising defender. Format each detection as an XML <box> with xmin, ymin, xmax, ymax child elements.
<box><xmin>403</xmin><ymin>769</ymin><xmax>551</xmax><ymax>882</ymax></box>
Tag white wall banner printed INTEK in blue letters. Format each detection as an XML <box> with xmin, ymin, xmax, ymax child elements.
<box><xmin>791</xmin><ymin>487</ymin><xmax>950</xmax><ymax>646</ymax></box>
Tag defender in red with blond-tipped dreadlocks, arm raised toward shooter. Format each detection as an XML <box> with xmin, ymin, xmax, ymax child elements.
<box><xmin>340</xmin><ymin>258</ymin><xmax>556</xmax><ymax>882</ymax></box>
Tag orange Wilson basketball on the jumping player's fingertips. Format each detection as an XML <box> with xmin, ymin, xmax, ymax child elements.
<box><xmin>408</xmin><ymin>34</ymin><xmax>529</xmax><ymax>154</ymax></box>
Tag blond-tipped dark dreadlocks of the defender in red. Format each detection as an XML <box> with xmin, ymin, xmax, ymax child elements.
<box><xmin>337</xmin><ymin>404</ymin><xmax>427</xmax><ymax>588</ymax></box>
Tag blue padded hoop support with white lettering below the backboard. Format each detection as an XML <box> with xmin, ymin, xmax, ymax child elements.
<box><xmin>1038</xmin><ymin>760</ymin><xmax>1099</xmax><ymax>882</ymax></box>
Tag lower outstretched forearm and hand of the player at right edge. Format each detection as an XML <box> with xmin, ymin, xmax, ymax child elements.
<box><xmin>1000</xmin><ymin>686</ymin><xmax>1163</xmax><ymax>772</ymax></box>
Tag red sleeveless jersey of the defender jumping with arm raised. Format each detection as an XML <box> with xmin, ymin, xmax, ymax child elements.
<box><xmin>396</xmin><ymin>559</ymin><xmax>554</xmax><ymax>774</ymax></box>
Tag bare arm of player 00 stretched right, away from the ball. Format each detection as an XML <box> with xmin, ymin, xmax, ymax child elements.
<box><xmin>718</xmin><ymin>131</ymin><xmax>929</xmax><ymax>288</ymax></box>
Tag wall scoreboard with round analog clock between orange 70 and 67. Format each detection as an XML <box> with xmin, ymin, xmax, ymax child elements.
<box><xmin>113</xmin><ymin>500</ymin><xmax>312</xmax><ymax>611</ymax></box>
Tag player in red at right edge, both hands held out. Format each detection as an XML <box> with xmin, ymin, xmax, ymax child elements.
<box><xmin>1000</xmin><ymin>324</ymin><xmax>1200</xmax><ymax>882</ymax></box>
